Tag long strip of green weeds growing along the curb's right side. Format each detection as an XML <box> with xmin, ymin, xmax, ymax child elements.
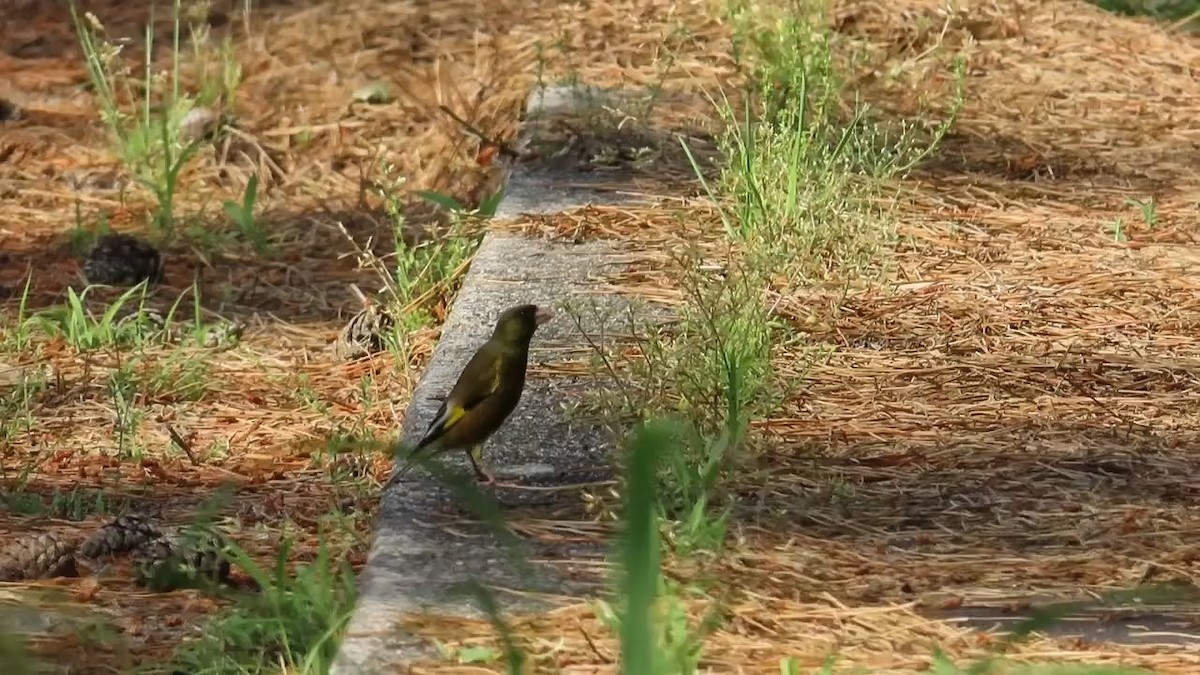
<box><xmin>597</xmin><ymin>2</ymin><xmax>965</xmax><ymax>552</ymax></box>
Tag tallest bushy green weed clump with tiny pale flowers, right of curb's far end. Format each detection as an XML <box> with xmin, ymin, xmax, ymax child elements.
<box><xmin>701</xmin><ymin>1</ymin><xmax>966</xmax><ymax>281</ymax></box>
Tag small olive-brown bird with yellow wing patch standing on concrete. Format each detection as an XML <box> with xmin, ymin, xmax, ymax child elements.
<box><xmin>384</xmin><ymin>305</ymin><xmax>553</xmax><ymax>488</ymax></box>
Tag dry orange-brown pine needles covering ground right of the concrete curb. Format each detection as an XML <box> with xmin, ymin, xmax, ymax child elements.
<box><xmin>460</xmin><ymin>1</ymin><xmax>1200</xmax><ymax>674</ymax></box>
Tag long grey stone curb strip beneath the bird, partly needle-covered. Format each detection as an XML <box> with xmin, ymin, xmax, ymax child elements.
<box><xmin>332</xmin><ymin>85</ymin><xmax>648</xmax><ymax>675</ymax></box>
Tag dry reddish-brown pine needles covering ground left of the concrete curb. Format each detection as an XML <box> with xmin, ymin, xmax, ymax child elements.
<box><xmin>0</xmin><ymin>0</ymin><xmax>731</xmax><ymax>673</ymax></box>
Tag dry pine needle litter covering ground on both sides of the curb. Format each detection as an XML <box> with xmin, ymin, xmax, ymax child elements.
<box><xmin>0</xmin><ymin>0</ymin><xmax>1200</xmax><ymax>673</ymax></box>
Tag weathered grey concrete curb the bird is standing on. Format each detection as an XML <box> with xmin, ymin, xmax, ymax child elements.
<box><xmin>331</xmin><ymin>86</ymin><xmax>657</xmax><ymax>675</ymax></box>
